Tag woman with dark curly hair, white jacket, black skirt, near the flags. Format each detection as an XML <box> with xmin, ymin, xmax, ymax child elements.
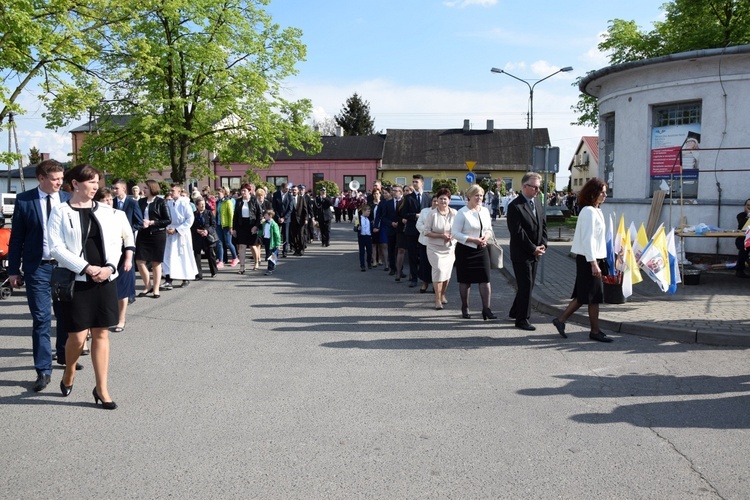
<box><xmin>552</xmin><ymin>177</ymin><xmax>612</xmax><ymax>342</ymax></box>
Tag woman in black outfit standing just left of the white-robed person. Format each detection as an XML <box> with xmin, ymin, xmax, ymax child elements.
<box><xmin>135</xmin><ymin>179</ymin><xmax>172</xmax><ymax>299</ymax></box>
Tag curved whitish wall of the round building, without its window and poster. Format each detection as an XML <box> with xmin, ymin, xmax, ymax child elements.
<box><xmin>586</xmin><ymin>46</ymin><xmax>750</xmax><ymax>254</ymax></box>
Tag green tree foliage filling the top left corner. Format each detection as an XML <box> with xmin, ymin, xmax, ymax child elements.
<box><xmin>0</xmin><ymin>0</ymin><xmax>127</xmax><ymax>167</ymax></box>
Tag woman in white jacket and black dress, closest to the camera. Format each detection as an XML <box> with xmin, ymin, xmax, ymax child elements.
<box><xmin>47</xmin><ymin>165</ymin><xmax>123</xmax><ymax>410</ymax></box>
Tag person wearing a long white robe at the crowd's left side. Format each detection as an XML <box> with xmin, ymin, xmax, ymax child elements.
<box><xmin>162</xmin><ymin>184</ymin><xmax>198</xmax><ymax>290</ymax></box>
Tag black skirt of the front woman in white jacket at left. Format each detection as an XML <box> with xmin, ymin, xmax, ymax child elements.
<box><xmin>64</xmin><ymin>281</ymin><xmax>119</xmax><ymax>332</ymax></box>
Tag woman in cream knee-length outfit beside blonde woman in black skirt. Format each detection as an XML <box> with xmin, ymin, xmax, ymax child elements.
<box><xmin>422</xmin><ymin>188</ymin><xmax>456</xmax><ymax>310</ymax></box>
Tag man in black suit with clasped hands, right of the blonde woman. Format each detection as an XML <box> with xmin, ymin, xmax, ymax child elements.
<box><xmin>507</xmin><ymin>172</ymin><xmax>547</xmax><ymax>331</ymax></box>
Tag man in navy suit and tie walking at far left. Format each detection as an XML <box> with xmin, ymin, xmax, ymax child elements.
<box><xmin>8</xmin><ymin>160</ymin><xmax>83</xmax><ymax>392</ymax></box>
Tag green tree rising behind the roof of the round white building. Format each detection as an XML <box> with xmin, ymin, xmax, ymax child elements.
<box><xmin>572</xmin><ymin>0</ymin><xmax>750</xmax><ymax>127</ymax></box>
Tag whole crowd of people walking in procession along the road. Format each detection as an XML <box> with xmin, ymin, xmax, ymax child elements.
<box><xmin>8</xmin><ymin>160</ymin><xmax>624</xmax><ymax>409</ymax></box>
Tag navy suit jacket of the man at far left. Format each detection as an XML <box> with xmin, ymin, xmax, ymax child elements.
<box><xmin>8</xmin><ymin>188</ymin><xmax>71</xmax><ymax>276</ymax></box>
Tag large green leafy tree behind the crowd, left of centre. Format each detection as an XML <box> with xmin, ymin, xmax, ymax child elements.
<box><xmin>75</xmin><ymin>0</ymin><xmax>320</xmax><ymax>182</ymax></box>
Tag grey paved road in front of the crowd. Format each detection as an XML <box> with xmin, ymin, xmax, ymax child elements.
<box><xmin>0</xmin><ymin>224</ymin><xmax>750</xmax><ymax>499</ymax></box>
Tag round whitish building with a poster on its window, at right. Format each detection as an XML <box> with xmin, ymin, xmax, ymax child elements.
<box><xmin>580</xmin><ymin>45</ymin><xmax>750</xmax><ymax>255</ymax></box>
